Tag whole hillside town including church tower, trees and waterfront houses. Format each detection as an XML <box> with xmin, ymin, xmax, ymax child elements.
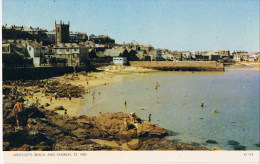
<box><xmin>2</xmin><ymin>21</ymin><xmax>260</xmax><ymax>68</ymax></box>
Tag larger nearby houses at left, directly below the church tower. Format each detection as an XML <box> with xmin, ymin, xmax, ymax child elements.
<box><xmin>2</xmin><ymin>40</ymin><xmax>88</xmax><ymax>67</ymax></box>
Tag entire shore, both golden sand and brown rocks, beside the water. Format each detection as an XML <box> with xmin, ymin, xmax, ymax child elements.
<box><xmin>3</xmin><ymin>66</ymin><xmax>207</xmax><ymax>151</ymax></box>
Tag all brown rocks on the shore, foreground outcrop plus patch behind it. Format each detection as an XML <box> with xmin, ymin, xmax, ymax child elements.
<box><xmin>3</xmin><ymin>67</ymin><xmax>208</xmax><ymax>151</ymax></box>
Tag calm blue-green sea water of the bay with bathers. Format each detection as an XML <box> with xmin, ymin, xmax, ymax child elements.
<box><xmin>79</xmin><ymin>68</ymin><xmax>260</xmax><ymax>150</ymax></box>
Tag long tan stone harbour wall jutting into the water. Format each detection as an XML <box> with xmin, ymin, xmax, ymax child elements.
<box><xmin>130</xmin><ymin>61</ymin><xmax>224</xmax><ymax>71</ymax></box>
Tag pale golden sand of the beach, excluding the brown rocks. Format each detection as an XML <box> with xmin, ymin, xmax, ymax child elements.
<box><xmin>21</xmin><ymin>65</ymin><xmax>156</xmax><ymax>116</ymax></box>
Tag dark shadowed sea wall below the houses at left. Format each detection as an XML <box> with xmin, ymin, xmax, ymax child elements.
<box><xmin>2</xmin><ymin>66</ymin><xmax>95</xmax><ymax>80</ymax></box>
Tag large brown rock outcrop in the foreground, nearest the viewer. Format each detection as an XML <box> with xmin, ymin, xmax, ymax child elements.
<box><xmin>3</xmin><ymin>108</ymin><xmax>207</xmax><ymax>151</ymax></box>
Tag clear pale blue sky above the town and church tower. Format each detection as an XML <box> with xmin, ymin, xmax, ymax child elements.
<box><xmin>2</xmin><ymin>0</ymin><xmax>260</xmax><ymax>52</ymax></box>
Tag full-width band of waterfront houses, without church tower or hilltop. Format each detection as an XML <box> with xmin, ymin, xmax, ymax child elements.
<box><xmin>2</xmin><ymin>39</ymin><xmax>260</xmax><ymax>67</ymax></box>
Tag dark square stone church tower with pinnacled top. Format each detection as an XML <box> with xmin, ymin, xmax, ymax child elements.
<box><xmin>55</xmin><ymin>21</ymin><xmax>70</xmax><ymax>45</ymax></box>
